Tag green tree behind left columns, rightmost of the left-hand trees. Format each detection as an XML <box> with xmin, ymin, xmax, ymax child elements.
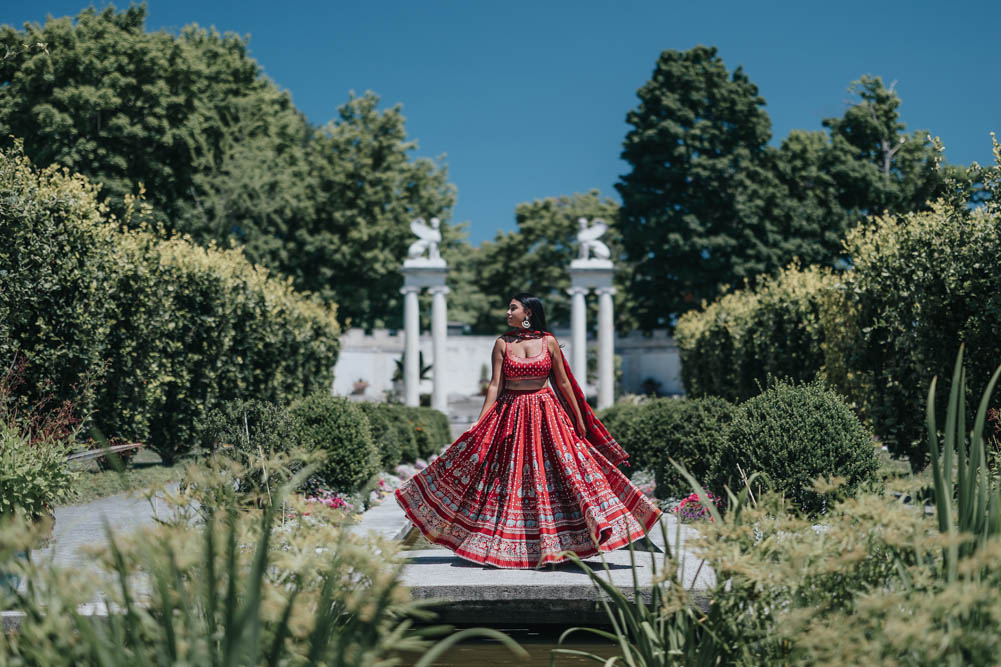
<box><xmin>298</xmin><ymin>92</ymin><xmax>455</xmax><ymax>327</ymax></box>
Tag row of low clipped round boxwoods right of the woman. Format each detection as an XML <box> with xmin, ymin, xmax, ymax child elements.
<box><xmin>602</xmin><ymin>380</ymin><xmax>878</xmax><ymax>514</ymax></box>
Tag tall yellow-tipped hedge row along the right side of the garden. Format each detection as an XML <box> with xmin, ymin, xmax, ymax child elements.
<box><xmin>676</xmin><ymin>192</ymin><xmax>1001</xmax><ymax>468</ymax></box>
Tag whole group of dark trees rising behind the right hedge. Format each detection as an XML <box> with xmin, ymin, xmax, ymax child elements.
<box><xmin>617</xmin><ymin>46</ymin><xmax>970</xmax><ymax>328</ymax></box>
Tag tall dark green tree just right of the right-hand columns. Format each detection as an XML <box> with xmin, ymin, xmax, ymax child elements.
<box><xmin>617</xmin><ymin>46</ymin><xmax>781</xmax><ymax>328</ymax></box>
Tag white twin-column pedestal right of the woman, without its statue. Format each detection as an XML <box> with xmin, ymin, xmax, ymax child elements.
<box><xmin>568</xmin><ymin>258</ymin><xmax>616</xmax><ymax>409</ymax></box>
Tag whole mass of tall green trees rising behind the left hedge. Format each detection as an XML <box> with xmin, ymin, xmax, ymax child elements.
<box><xmin>0</xmin><ymin>5</ymin><xmax>454</xmax><ymax>326</ymax></box>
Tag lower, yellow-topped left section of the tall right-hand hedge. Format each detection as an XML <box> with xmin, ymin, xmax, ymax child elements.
<box><xmin>675</xmin><ymin>264</ymin><xmax>851</xmax><ymax>401</ymax></box>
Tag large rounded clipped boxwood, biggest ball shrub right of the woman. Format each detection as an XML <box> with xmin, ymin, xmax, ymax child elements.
<box><xmin>713</xmin><ymin>380</ymin><xmax>878</xmax><ymax>514</ymax></box>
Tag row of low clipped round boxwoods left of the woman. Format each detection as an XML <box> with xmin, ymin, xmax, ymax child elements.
<box><xmin>198</xmin><ymin>392</ymin><xmax>450</xmax><ymax>493</ymax></box>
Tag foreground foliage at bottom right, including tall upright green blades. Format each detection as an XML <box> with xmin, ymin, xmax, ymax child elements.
<box><xmin>568</xmin><ymin>344</ymin><xmax>1001</xmax><ymax>667</ymax></box>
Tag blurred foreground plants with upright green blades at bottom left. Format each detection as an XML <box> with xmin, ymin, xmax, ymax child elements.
<box><xmin>0</xmin><ymin>454</ymin><xmax>521</xmax><ymax>667</ymax></box>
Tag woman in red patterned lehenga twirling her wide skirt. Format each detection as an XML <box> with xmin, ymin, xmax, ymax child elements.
<box><xmin>396</xmin><ymin>293</ymin><xmax>661</xmax><ymax>568</ymax></box>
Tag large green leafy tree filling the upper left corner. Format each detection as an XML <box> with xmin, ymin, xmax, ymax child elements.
<box><xmin>0</xmin><ymin>4</ymin><xmax>274</xmax><ymax>220</ymax></box>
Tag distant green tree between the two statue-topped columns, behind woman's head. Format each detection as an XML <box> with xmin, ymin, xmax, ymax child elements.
<box><xmin>460</xmin><ymin>190</ymin><xmax>631</xmax><ymax>332</ymax></box>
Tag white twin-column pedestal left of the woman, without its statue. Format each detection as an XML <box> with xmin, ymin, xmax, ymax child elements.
<box><xmin>400</xmin><ymin>257</ymin><xmax>448</xmax><ymax>412</ymax></box>
